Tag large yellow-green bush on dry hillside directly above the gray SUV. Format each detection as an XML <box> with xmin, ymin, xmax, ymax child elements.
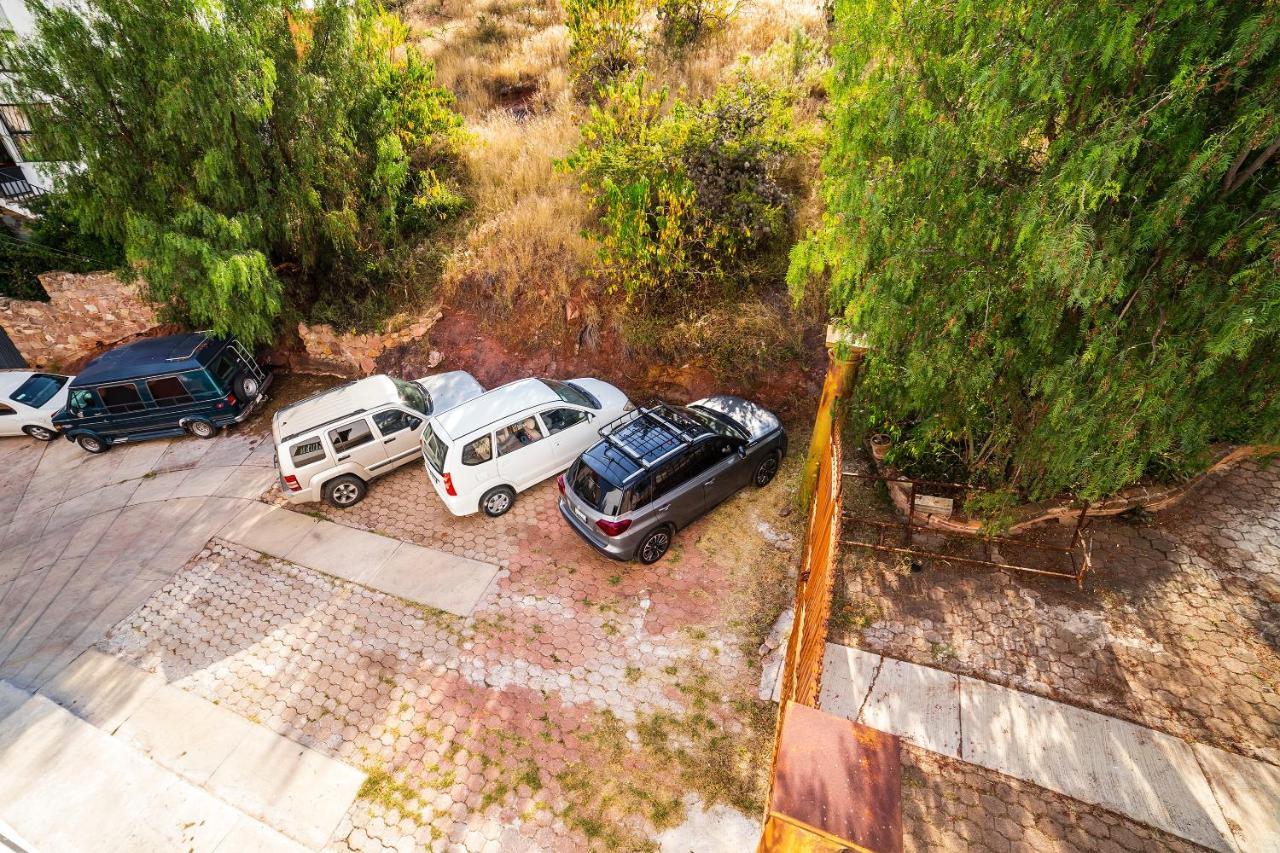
<box><xmin>566</xmin><ymin>74</ymin><xmax>804</xmax><ymax>302</ymax></box>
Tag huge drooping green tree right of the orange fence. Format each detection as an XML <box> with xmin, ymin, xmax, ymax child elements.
<box><xmin>791</xmin><ymin>0</ymin><xmax>1280</xmax><ymax>497</ymax></box>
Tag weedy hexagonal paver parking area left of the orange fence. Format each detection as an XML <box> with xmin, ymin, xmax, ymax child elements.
<box><xmin>102</xmin><ymin>462</ymin><xmax>800</xmax><ymax>850</ymax></box>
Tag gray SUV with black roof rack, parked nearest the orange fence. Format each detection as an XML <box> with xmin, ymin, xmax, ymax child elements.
<box><xmin>557</xmin><ymin>396</ymin><xmax>787</xmax><ymax>564</ymax></box>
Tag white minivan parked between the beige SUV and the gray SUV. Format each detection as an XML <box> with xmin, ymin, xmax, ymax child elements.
<box><xmin>422</xmin><ymin>379</ymin><xmax>632</xmax><ymax>517</ymax></box>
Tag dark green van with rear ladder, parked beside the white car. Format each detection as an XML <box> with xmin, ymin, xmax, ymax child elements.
<box><xmin>54</xmin><ymin>332</ymin><xmax>271</xmax><ymax>453</ymax></box>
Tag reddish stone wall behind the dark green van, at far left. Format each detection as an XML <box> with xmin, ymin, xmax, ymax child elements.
<box><xmin>0</xmin><ymin>273</ymin><xmax>159</xmax><ymax>370</ymax></box>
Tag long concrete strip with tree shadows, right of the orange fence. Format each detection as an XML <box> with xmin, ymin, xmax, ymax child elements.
<box><xmin>820</xmin><ymin>643</ymin><xmax>1280</xmax><ymax>853</ymax></box>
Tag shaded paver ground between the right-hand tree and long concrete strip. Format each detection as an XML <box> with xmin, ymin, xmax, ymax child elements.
<box><xmin>833</xmin><ymin>462</ymin><xmax>1280</xmax><ymax>763</ymax></box>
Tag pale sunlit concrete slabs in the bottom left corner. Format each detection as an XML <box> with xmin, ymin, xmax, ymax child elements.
<box><xmin>0</xmin><ymin>649</ymin><xmax>365</xmax><ymax>853</ymax></box>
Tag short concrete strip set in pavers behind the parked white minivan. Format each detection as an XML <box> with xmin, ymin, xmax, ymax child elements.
<box><xmin>218</xmin><ymin>503</ymin><xmax>498</xmax><ymax>616</ymax></box>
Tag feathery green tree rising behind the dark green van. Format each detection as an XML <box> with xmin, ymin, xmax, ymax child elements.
<box><xmin>6</xmin><ymin>0</ymin><xmax>461</xmax><ymax>342</ymax></box>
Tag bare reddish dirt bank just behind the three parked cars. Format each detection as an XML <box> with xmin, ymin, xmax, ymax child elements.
<box><xmin>378</xmin><ymin>309</ymin><xmax>826</xmax><ymax>423</ymax></box>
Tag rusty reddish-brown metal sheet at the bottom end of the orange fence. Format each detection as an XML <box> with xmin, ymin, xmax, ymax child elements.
<box><xmin>769</xmin><ymin>702</ymin><xmax>902</xmax><ymax>853</ymax></box>
